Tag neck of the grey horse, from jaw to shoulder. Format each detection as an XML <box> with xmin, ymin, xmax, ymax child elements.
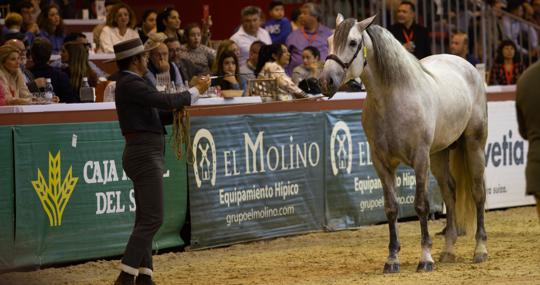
<box><xmin>361</xmin><ymin>26</ymin><xmax>429</xmax><ymax>94</ymax></box>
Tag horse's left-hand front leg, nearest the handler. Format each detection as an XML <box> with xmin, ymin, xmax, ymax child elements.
<box><xmin>373</xmin><ymin>152</ymin><xmax>401</xmax><ymax>273</ymax></box>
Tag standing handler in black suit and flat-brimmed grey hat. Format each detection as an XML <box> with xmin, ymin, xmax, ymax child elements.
<box><xmin>114</xmin><ymin>38</ymin><xmax>210</xmax><ymax>285</ymax></box>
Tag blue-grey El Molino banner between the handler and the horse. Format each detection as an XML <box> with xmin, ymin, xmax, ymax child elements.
<box><xmin>189</xmin><ymin>113</ymin><xmax>325</xmax><ymax>248</ymax></box>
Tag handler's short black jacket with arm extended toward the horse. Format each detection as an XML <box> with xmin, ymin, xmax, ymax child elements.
<box><xmin>115</xmin><ymin>71</ymin><xmax>191</xmax><ymax>134</ymax></box>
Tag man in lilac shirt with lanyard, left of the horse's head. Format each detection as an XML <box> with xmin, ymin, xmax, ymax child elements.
<box><xmin>286</xmin><ymin>3</ymin><xmax>332</xmax><ymax>74</ymax></box>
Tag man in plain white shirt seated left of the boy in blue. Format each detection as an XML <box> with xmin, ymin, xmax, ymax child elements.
<box><xmin>230</xmin><ymin>6</ymin><xmax>272</xmax><ymax>68</ymax></box>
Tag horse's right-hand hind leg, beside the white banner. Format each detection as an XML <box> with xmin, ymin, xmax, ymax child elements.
<box><xmin>465</xmin><ymin>136</ymin><xmax>488</xmax><ymax>263</ymax></box>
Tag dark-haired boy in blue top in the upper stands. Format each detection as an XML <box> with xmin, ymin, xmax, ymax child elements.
<box><xmin>264</xmin><ymin>0</ymin><xmax>292</xmax><ymax>44</ymax></box>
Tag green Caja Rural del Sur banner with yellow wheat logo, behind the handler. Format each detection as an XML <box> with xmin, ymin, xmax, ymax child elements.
<box><xmin>14</xmin><ymin>122</ymin><xmax>187</xmax><ymax>266</ymax></box>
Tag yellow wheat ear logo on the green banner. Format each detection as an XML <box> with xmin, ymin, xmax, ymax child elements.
<box><xmin>32</xmin><ymin>151</ymin><xmax>79</xmax><ymax>227</ymax></box>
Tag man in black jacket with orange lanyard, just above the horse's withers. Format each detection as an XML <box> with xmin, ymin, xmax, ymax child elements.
<box><xmin>389</xmin><ymin>1</ymin><xmax>431</xmax><ymax>59</ymax></box>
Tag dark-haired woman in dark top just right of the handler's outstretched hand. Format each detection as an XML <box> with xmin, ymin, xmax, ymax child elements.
<box><xmin>212</xmin><ymin>51</ymin><xmax>245</xmax><ymax>90</ymax></box>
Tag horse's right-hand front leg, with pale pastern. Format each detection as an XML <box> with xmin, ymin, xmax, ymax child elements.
<box><xmin>413</xmin><ymin>151</ymin><xmax>434</xmax><ymax>272</ymax></box>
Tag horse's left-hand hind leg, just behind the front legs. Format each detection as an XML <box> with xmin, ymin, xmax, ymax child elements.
<box><xmin>431</xmin><ymin>149</ymin><xmax>457</xmax><ymax>262</ymax></box>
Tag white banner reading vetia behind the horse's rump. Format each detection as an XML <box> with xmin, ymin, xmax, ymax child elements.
<box><xmin>485</xmin><ymin>101</ymin><xmax>535</xmax><ymax>209</ymax></box>
